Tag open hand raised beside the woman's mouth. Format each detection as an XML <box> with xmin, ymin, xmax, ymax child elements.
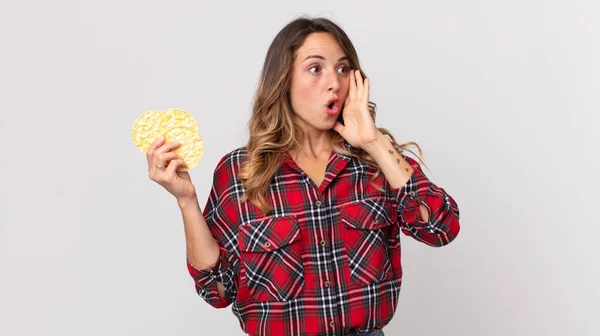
<box><xmin>333</xmin><ymin>70</ymin><xmax>379</xmax><ymax>149</ymax></box>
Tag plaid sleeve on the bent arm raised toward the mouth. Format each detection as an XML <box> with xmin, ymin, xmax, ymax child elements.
<box><xmin>390</xmin><ymin>156</ymin><xmax>460</xmax><ymax>247</ymax></box>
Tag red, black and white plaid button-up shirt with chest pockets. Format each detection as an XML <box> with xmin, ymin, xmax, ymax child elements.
<box><xmin>187</xmin><ymin>143</ymin><xmax>460</xmax><ymax>336</ymax></box>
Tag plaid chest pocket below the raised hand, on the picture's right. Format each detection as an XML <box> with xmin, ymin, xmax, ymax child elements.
<box><xmin>341</xmin><ymin>198</ymin><xmax>397</xmax><ymax>286</ymax></box>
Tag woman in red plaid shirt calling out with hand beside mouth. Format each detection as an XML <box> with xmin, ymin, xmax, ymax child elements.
<box><xmin>147</xmin><ymin>18</ymin><xmax>459</xmax><ymax>335</ymax></box>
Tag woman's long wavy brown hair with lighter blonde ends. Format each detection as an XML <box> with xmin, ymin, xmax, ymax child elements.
<box><xmin>239</xmin><ymin>17</ymin><xmax>422</xmax><ymax>214</ymax></box>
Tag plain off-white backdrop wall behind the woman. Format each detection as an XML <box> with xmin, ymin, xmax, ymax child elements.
<box><xmin>0</xmin><ymin>0</ymin><xmax>600</xmax><ymax>336</ymax></box>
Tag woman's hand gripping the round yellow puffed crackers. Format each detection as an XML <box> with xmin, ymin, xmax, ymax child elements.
<box><xmin>146</xmin><ymin>137</ymin><xmax>196</xmax><ymax>202</ymax></box>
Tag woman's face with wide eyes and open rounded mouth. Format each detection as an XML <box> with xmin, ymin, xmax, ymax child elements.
<box><xmin>290</xmin><ymin>33</ymin><xmax>351</xmax><ymax>131</ymax></box>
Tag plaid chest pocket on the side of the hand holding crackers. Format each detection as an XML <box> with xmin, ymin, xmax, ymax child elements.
<box><xmin>238</xmin><ymin>216</ymin><xmax>304</xmax><ymax>302</ymax></box>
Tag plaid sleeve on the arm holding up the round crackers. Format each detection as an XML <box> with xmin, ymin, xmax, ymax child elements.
<box><xmin>186</xmin><ymin>159</ymin><xmax>239</xmax><ymax>308</ymax></box>
